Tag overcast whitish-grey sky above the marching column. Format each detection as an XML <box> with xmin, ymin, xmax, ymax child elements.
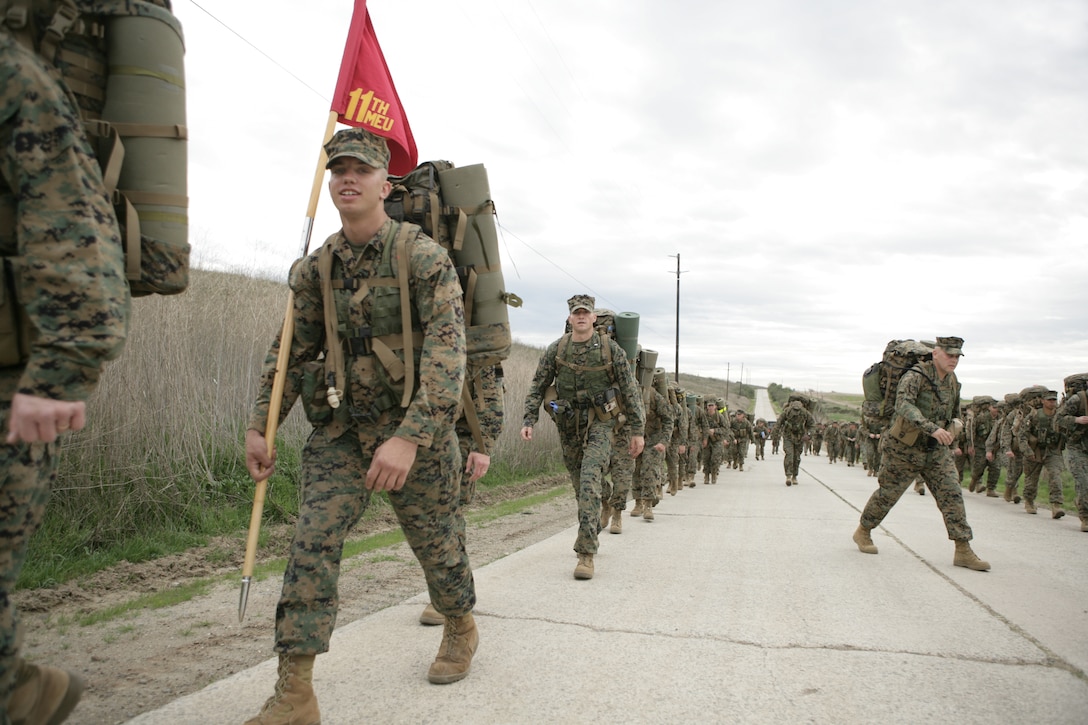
<box><xmin>174</xmin><ymin>0</ymin><xmax>1088</xmax><ymax>397</ymax></box>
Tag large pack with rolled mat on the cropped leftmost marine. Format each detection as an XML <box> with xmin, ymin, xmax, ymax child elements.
<box><xmin>0</xmin><ymin>0</ymin><xmax>189</xmax><ymax>297</ymax></box>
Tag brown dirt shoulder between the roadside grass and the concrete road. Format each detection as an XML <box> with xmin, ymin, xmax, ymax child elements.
<box><xmin>16</xmin><ymin>476</ymin><xmax>577</xmax><ymax>725</ymax></box>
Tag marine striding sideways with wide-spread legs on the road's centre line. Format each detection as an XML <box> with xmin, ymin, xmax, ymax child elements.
<box><xmin>853</xmin><ymin>337</ymin><xmax>990</xmax><ymax>572</ymax></box>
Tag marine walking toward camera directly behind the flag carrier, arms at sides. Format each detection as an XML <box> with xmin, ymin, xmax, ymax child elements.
<box><xmin>521</xmin><ymin>295</ymin><xmax>645</xmax><ymax>579</ymax></box>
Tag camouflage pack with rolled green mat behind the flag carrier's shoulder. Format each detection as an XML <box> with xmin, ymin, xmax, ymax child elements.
<box><xmin>385</xmin><ymin>161</ymin><xmax>521</xmax><ymax>369</ymax></box>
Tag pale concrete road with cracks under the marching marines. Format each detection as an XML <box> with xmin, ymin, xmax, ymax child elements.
<box><xmin>131</xmin><ymin>402</ymin><xmax>1088</xmax><ymax>725</ymax></box>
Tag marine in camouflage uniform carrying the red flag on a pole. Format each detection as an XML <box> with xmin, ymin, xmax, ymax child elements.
<box><xmin>246</xmin><ymin>128</ymin><xmax>479</xmax><ymax>725</ymax></box>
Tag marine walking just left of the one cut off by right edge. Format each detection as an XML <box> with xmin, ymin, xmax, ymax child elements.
<box><xmin>1016</xmin><ymin>390</ymin><xmax>1065</xmax><ymax>518</ymax></box>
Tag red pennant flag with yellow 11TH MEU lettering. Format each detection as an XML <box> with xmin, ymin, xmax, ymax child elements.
<box><xmin>332</xmin><ymin>0</ymin><xmax>419</xmax><ymax>176</ymax></box>
